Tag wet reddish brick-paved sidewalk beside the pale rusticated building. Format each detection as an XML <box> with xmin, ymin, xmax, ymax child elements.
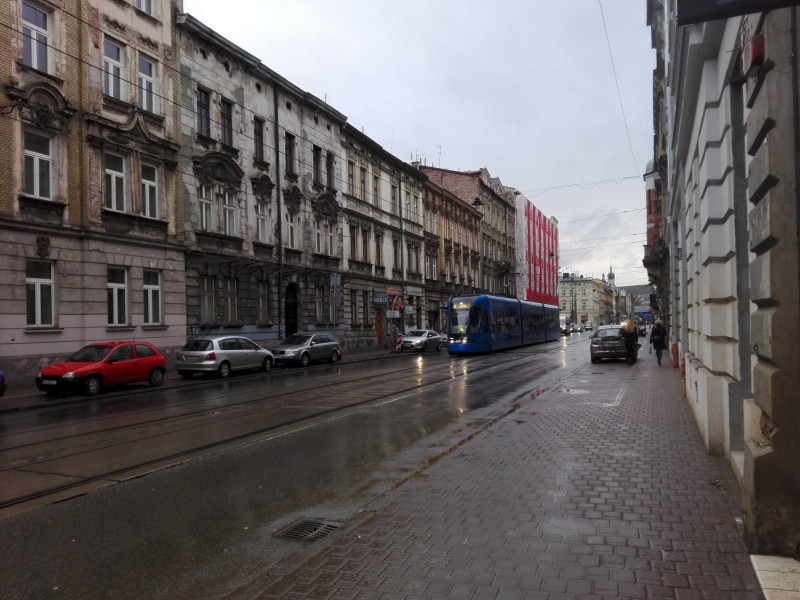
<box><xmin>247</xmin><ymin>354</ymin><xmax>780</xmax><ymax>600</ymax></box>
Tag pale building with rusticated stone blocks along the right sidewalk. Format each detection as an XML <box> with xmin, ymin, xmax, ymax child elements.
<box><xmin>648</xmin><ymin>0</ymin><xmax>800</xmax><ymax>558</ymax></box>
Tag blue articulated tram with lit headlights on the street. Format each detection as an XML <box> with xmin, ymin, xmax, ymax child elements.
<box><xmin>447</xmin><ymin>294</ymin><xmax>561</xmax><ymax>354</ymax></box>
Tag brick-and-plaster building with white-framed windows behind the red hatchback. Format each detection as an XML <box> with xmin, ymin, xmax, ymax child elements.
<box><xmin>0</xmin><ymin>0</ymin><xmax>185</xmax><ymax>381</ymax></box>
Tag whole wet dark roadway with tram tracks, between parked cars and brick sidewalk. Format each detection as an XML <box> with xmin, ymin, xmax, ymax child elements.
<box><xmin>0</xmin><ymin>342</ymin><xmax>588</xmax><ymax>598</ymax></box>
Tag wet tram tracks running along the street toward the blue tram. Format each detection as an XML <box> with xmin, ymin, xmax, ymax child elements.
<box><xmin>0</xmin><ymin>340</ymin><xmax>578</xmax><ymax>518</ymax></box>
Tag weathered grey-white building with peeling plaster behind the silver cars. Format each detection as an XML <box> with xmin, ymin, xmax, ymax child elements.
<box><xmin>177</xmin><ymin>14</ymin><xmax>346</xmax><ymax>342</ymax></box>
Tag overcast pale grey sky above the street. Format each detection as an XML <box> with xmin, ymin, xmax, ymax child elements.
<box><xmin>184</xmin><ymin>0</ymin><xmax>655</xmax><ymax>285</ymax></box>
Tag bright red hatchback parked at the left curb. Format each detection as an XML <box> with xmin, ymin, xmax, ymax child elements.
<box><xmin>36</xmin><ymin>342</ymin><xmax>165</xmax><ymax>396</ymax></box>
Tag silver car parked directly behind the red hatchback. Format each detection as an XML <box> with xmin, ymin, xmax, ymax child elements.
<box><xmin>175</xmin><ymin>335</ymin><xmax>275</xmax><ymax>379</ymax></box>
